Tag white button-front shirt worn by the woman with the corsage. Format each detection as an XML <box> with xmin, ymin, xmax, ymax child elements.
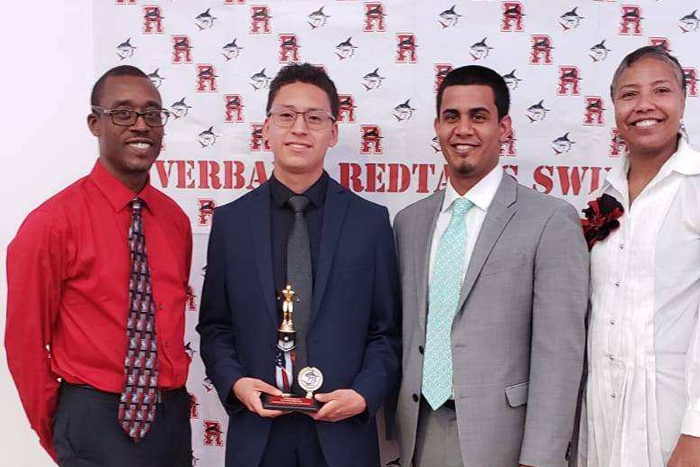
<box><xmin>579</xmin><ymin>139</ymin><xmax>700</xmax><ymax>467</ymax></box>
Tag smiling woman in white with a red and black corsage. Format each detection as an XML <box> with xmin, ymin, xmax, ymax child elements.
<box><xmin>579</xmin><ymin>47</ymin><xmax>700</xmax><ymax>467</ymax></box>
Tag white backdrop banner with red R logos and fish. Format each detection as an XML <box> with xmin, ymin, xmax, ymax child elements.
<box><xmin>94</xmin><ymin>0</ymin><xmax>700</xmax><ymax>467</ymax></box>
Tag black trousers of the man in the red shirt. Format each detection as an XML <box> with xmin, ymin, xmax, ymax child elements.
<box><xmin>53</xmin><ymin>384</ymin><xmax>192</xmax><ymax>467</ymax></box>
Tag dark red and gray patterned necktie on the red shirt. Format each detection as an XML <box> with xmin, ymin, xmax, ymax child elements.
<box><xmin>119</xmin><ymin>198</ymin><xmax>158</xmax><ymax>442</ymax></box>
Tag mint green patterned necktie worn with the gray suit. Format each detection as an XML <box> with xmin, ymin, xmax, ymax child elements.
<box><xmin>423</xmin><ymin>198</ymin><xmax>474</xmax><ymax>410</ymax></box>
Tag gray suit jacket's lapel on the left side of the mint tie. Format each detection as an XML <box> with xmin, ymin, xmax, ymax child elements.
<box><xmin>413</xmin><ymin>190</ymin><xmax>445</xmax><ymax>331</ymax></box>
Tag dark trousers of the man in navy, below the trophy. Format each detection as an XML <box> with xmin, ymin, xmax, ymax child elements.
<box><xmin>258</xmin><ymin>413</ymin><xmax>328</xmax><ymax>467</ymax></box>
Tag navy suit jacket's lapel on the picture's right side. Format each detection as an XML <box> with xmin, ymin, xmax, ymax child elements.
<box><xmin>309</xmin><ymin>178</ymin><xmax>348</xmax><ymax>327</ymax></box>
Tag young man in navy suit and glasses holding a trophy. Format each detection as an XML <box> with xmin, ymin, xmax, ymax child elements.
<box><xmin>197</xmin><ymin>64</ymin><xmax>400</xmax><ymax>467</ymax></box>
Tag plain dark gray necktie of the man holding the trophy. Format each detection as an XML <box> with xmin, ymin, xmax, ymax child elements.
<box><xmin>287</xmin><ymin>195</ymin><xmax>313</xmax><ymax>394</ymax></box>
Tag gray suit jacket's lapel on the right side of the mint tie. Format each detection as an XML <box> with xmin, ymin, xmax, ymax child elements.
<box><xmin>457</xmin><ymin>175</ymin><xmax>518</xmax><ymax>313</ymax></box>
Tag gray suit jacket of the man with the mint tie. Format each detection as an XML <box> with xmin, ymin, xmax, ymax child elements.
<box><xmin>395</xmin><ymin>176</ymin><xmax>589</xmax><ymax>467</ymax></box>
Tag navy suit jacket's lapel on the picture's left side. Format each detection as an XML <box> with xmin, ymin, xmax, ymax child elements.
<box><xmin>249</xmin><ymin>183</ymin><xmax>278</xmax><ymax>323</ymax></box>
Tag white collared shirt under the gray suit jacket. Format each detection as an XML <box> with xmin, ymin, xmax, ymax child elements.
<box><xmin>428</xmin><ymin>165</ymin><xmax>504</xmax><ymax>287</ymax></box>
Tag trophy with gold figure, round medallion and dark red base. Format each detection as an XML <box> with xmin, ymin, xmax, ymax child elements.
<box><xmin>262</xmin><ymin>285</ymin><xmax>323</xmax><ymax>412</ymax></box>
